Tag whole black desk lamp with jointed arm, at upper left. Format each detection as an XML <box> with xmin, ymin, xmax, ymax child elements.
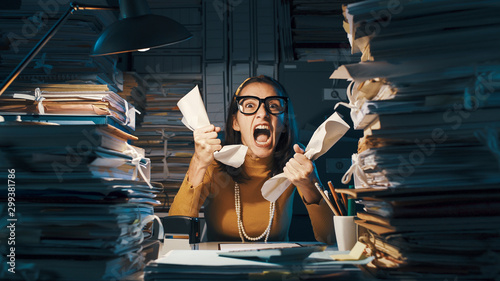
<box><xmin>0</xmin><ymin>0</ymin><xmax>192</xmax><ymax>95</ymax></box>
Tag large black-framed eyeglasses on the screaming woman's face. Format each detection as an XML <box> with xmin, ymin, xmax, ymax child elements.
<box><xmin>236</xmin><ymin>96</ymin><xmax>288</xmax><ymax>115</ymax></box>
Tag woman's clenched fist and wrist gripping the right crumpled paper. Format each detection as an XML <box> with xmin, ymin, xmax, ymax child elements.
<box><xmin>283</xmin><ymin>144</ymin><xmax>322</xmax><ymax>203</ymax></box>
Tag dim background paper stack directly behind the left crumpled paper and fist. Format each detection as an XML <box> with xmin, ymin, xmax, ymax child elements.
<box><xmin>134</xmin><ymin>81</ymin><xmax>195</xmax><ymax>211</ymax></box>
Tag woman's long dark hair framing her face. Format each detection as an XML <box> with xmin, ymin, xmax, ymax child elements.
<box><xmin>219</xmin><ymin>75</ymin><xmax>297</xmax><ymax>182</ymax></box>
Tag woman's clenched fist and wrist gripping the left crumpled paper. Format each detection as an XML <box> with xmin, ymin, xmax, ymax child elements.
<box><xmin>188</xmin><ymin>125</ymin><xmax>222</xmax><ymax>186</ymax></box>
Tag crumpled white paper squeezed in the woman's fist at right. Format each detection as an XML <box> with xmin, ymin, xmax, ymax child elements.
<box><xmin>261</xmin><ymin>112</ymin><xmax>349</xmax><ymax>202</ymax></box>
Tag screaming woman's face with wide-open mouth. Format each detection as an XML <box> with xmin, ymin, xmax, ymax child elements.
<box><xmin>233</xmin><ymin>82</ymin><xmax>286</xmax><ymax>158</ymax></box>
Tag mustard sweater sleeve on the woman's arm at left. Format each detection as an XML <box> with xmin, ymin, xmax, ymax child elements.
<box><xmin>168</xmin><ymin>162</ymin><xmax>217</xmax><ymax>217</ymax></box>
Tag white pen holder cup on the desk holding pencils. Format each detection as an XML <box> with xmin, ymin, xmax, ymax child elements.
<box><xmin>333</xmin><ymin>216</ymin><xmax>358</xmax><ymax>251</ymax></box>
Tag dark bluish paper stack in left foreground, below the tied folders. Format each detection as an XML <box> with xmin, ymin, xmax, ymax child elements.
<box><xmin>0</xmin><ymin>121</ymin><xmax>161</xmax><ymax>280</ymax></box>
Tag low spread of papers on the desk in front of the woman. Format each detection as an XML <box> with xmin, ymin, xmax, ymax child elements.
<box><xmin>144</xmin><ymin>250</ymin><xmax>370</xmax><ymax>281</ymax></box>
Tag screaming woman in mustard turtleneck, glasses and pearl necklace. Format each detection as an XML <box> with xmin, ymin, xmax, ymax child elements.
<box><xmin>169</xmin><ymin>76</ymin><xmax>335</xmax><ymax>244</ymax></box>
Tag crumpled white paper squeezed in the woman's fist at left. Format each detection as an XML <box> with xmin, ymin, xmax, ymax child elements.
<box><xmin>177</xmin><ymin>86</ymin><xmax>248</xmax><ymax>168</ymax></box>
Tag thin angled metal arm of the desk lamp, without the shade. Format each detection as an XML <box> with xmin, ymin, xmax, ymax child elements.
<box><xmin>0</xmin><ymin>3</ymin><xmax>118</xmax><ymax>96</ymax></box>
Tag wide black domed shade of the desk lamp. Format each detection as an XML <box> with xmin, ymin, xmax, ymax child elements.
<box><xmin>90</xmin><ymin>14</ymin><xmax>192</xmax><ymax>56</ymax></box>
